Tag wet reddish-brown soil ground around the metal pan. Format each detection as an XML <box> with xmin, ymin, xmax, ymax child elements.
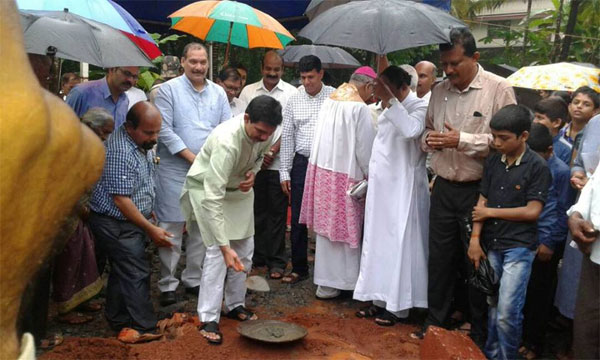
<box><xmin>39</xmin><ymin>236</ymin><xmax>420</xmax><ymax>360</ymax></box>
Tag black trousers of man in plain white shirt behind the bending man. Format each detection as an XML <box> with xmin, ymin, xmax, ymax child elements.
<box><xmin>252</xmin><ymin>170</ymin><xmax>288</xmax><ymax>270</ymax></box>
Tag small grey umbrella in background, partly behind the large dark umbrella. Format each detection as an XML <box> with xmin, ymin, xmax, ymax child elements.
<box><xmin>280</xmin><ymin>45</ymin><xmax>360</xmax><ymax>69</ymax></box>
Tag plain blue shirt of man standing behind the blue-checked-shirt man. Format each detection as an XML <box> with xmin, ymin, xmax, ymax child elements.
<box><xmin>66</xmin><ymin>77</ymin><xmax>129</xmax><ymax>129</ymax></box>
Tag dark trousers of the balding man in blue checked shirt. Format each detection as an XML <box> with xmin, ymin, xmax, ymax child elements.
<box><xmin>89</xmin><ymin>212</ymin><xmax>156</xmax><ymax>332</ymax></box>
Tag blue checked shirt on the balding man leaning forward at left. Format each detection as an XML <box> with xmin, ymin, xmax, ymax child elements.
<box><xmin>90</xmin><ymin>126</ymin><xmax>155</xmax><ymax>220</ymax></box>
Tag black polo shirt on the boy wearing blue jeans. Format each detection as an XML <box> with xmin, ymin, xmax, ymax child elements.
<box><xmin>480</xmin><ymin>146</ymin><xmax>552</xmax><ymax>250</ymax></box>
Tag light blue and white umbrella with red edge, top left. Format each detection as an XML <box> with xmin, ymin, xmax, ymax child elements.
<box><xmin>17</xmin><ymin>0</ymin><xmax>162</xmax><ymax>59</ymax></box>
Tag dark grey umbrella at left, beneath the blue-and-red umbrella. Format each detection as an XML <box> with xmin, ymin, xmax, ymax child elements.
<box><xmin>19</xmin><ymin>11</ymin><xmax>153</xmax><ymax>68</ymax></box>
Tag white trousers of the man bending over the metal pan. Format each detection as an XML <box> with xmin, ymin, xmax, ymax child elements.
<box><xmin>198</xmin><ymin>236</ymin><xmax>254</xmax><ymax>322</ymax></box>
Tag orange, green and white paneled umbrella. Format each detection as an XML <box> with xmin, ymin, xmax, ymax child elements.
<box><xmin>169</xmin><ymin>0</ymin><xmax>294</xmax><ymax>59</ymax></box>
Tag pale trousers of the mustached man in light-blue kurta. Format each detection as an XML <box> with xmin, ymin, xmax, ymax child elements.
<box><xmin>158</xmin><ymin>221</ymin><xmax>206</xmax><ymax>292</ymax></box>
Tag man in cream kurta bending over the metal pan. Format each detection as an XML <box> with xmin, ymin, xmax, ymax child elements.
<box><xmin>181</xmin><ymin>95</ymin><xmax>281</xmax><ymax>343</ymax></box>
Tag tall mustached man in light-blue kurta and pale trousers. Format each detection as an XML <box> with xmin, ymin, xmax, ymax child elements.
<box><xmin>154</xmin><ymin>43</ymin><xmax>231</xmax><ymax>306</ymax></box>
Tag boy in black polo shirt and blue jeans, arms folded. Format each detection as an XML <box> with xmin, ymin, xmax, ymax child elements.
<box><xmin>468</xmin><ymin>105</ymin><xmax>552</xmax><ymax>359</ymax></box>
